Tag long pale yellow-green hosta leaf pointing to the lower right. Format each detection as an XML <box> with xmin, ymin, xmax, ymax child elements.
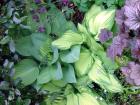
<box><xmin>88</xmin><ymin>58</ymin><xmax>123</xmax><ymax>93</ymax></box>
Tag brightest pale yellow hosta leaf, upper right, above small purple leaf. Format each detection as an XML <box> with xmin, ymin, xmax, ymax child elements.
<box><xmin>89</xmin><ymin>9</ymin><xmax>115</xmax><ymax>35</ymax></box>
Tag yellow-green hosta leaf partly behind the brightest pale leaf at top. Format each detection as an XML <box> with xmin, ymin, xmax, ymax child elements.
<box><xmin>84</xmin><ymin>5</ymin><xmax>101</xmax><ymax>26</ymax></box>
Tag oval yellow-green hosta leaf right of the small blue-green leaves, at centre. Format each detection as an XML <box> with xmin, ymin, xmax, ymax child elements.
<box><xmin>75</xmin><ymin>49</ymin><xmax>93</xmax><ymax>76</ymax></box>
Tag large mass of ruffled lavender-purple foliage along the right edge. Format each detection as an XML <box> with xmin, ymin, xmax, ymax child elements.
<box><xmin>107</xmin><ymin>0</ymin><xmax>140</xmax><ymax>86</ymax></box>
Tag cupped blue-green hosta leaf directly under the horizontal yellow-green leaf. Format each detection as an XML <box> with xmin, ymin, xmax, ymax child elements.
<box><xmin>60</xmin><ymin>45</ymin><xmax>81</xmax><ymax>63</ymax></box>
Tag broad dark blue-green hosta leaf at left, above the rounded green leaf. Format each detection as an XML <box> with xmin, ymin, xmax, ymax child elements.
<box><xmin>15</xmin><ymin>33</ymin><xmax>46</xmax><ymax>61</ymax></box>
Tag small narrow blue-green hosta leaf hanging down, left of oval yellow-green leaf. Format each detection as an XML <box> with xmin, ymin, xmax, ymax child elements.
<box><xmin>63</xmin><ymin>64</ymin><xmax>76</xmax><ymax>83</ymax></box>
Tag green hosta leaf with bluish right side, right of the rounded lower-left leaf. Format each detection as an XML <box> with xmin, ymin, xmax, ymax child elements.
<box><xmin>37</xmin><ymin>62</ymin><xmax>63</xmax><ymax>84</ymax></box>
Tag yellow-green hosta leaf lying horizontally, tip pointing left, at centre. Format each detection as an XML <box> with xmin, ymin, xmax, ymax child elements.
<box><xmin>52</xmin><ymin>30</ymin><xmax>86</xmax><ymax>50</ymax></box>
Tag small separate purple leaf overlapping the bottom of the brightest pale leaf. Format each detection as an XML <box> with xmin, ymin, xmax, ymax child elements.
<box><xmin>99</xmin><ymin>29</ymin><xmax>113</xmax><ymax>43</ymax></box>
